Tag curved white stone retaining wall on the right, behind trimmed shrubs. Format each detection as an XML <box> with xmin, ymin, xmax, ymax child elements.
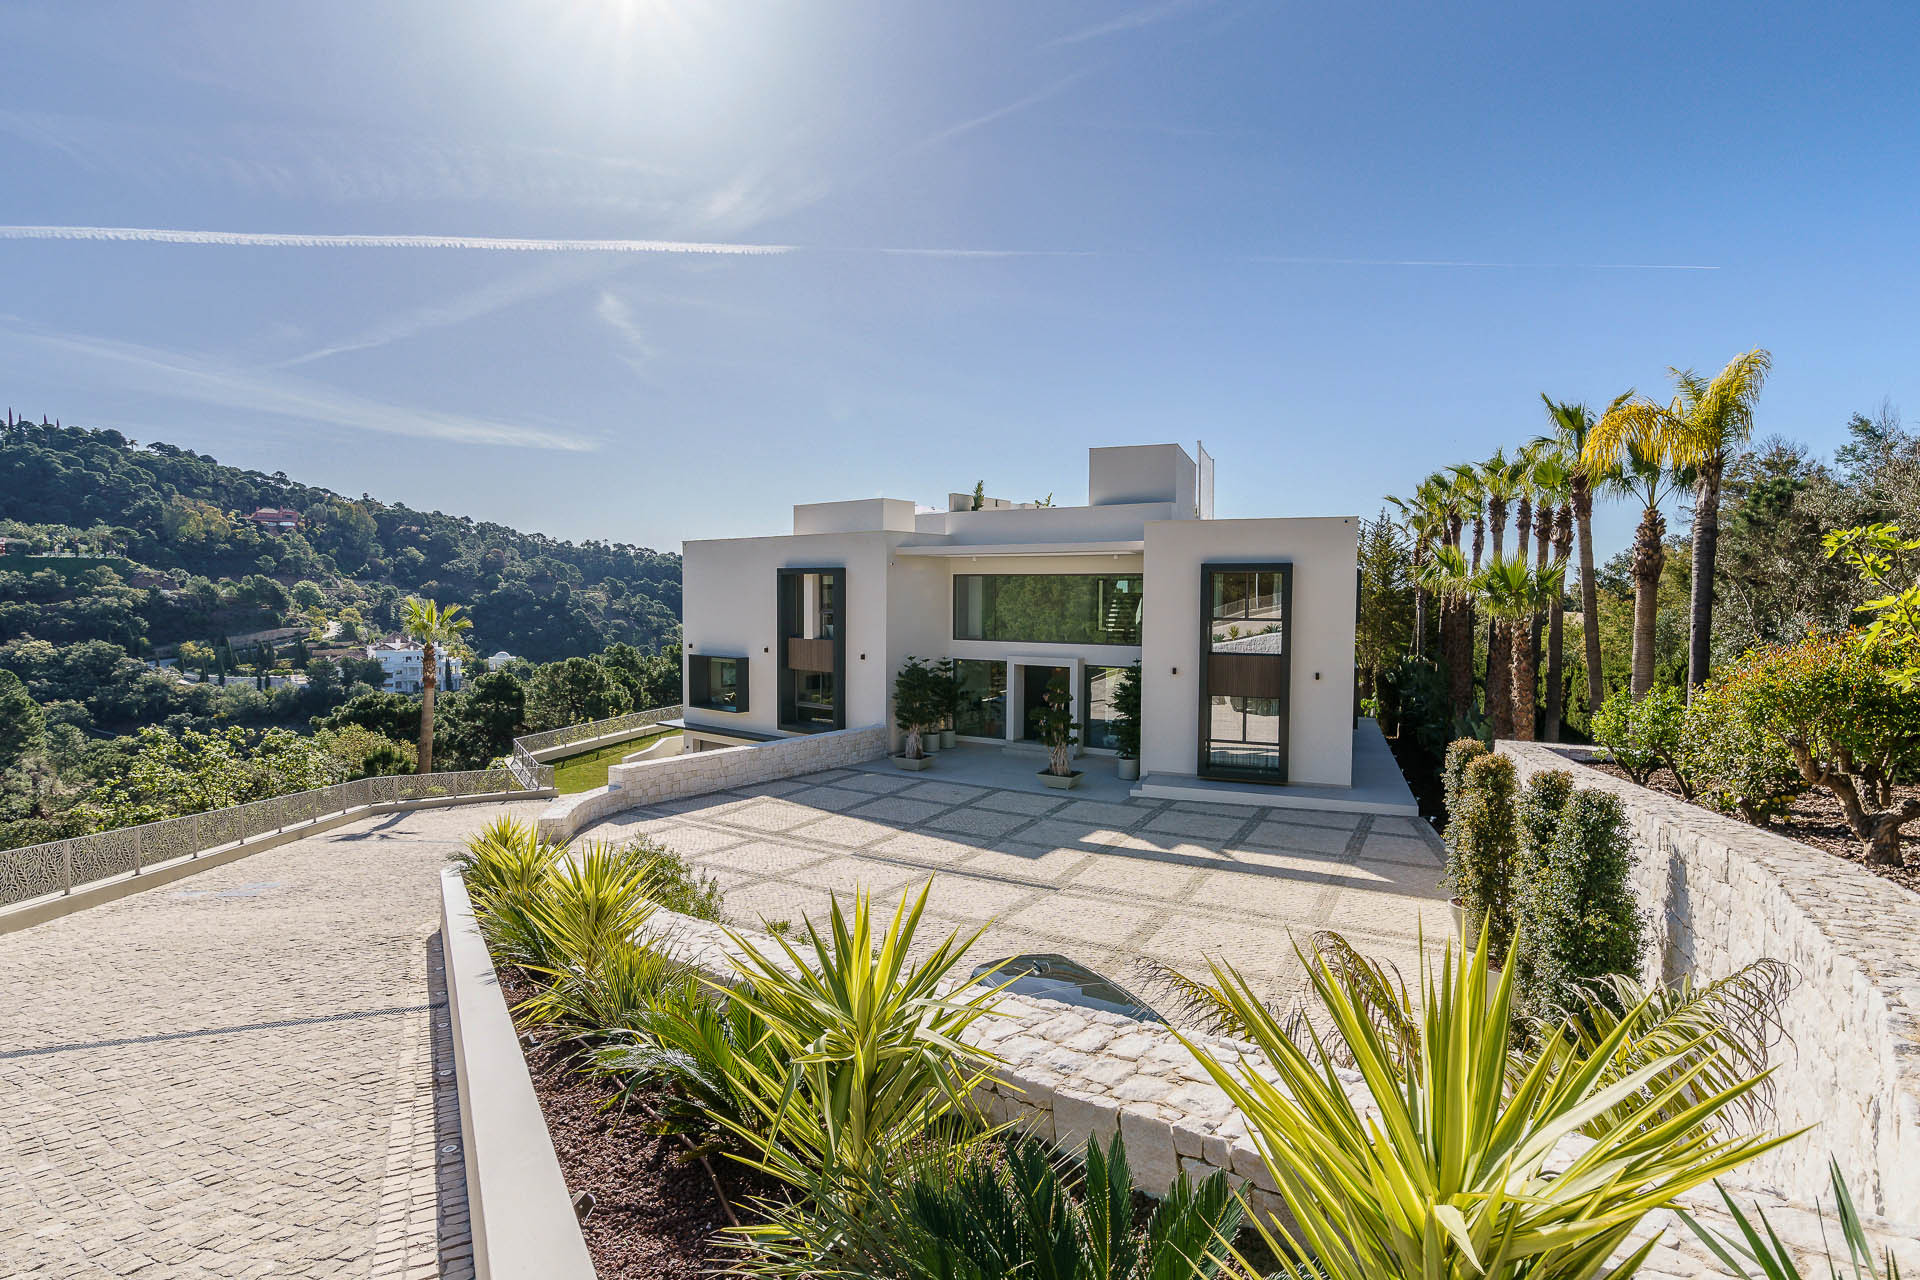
<box><xmin>1500</xmin><ymin>743</ymin><xmax>1920</xmax><ymax>1221</ymax></box>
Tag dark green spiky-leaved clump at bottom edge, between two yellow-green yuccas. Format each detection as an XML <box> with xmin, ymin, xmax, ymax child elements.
<box><xmin>735</xmin><ymin>1132</ymin><xmax>1244</xmax><ymax>1280</ymax></box>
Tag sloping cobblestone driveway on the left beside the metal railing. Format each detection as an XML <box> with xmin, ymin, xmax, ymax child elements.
<box><xmin>0</xmin><ymin>804</ymin><xmax>540</xmax><ymax>1280</ymax></box>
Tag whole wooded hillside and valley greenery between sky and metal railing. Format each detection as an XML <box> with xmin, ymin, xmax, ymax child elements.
<box><xmin>0</xmin><ymin>412</ymin><xmax>680</xmax><ymax>848</ymax></box>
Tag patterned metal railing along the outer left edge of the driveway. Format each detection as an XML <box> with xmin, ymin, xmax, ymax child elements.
<box><xmin>0</xmin><ymin>768</ymin><xmax>526</xmax><ymax>906</ymax></box>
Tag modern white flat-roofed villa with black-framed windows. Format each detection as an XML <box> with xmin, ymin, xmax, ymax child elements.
<box><xmin>684</xmin><ymin>445</ymin><xmax>1411</xmax><ymax>812</ymax></box>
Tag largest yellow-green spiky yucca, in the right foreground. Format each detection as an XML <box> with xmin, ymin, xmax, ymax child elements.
<box><xmin>1188</xmin><ymin>931</ymin><xmax>1786</xmax><ymax>1280</ymax></box>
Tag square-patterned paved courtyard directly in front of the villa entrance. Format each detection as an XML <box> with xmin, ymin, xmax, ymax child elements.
<box><xmin>584</xmin><ymin>766</ymin><xmax>1452</xmax><ymax>998</ymax></box>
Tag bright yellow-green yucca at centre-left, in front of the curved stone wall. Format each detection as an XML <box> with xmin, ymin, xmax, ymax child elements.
<box><xmin>714</xmin><ymin>879</ymin><xmax>996</xmax><ymax>1186</ymax></box>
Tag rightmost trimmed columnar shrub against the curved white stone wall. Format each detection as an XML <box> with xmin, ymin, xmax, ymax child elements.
<box><xmin>1515</xmin><ymin>789</ymin><xmax>1645</xmax><ymax>1015</ymax></box>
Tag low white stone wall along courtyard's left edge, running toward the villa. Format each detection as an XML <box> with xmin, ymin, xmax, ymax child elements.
<box><xmin>540</xmin><ymin>725</ymin><xmax>887</xmax><ymax>841</ymax></box>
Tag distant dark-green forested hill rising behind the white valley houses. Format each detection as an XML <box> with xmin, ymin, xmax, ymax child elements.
<box><xmin>0</xmin><ymin>422</ymin><xmax>680</xmax><ymax>660</ymax></box>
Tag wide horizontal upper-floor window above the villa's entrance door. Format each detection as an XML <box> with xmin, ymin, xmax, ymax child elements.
<box><xmin>954</xmin><ymin>574</ymin><xmax>1142</xmax><ymax>645</ymax></box>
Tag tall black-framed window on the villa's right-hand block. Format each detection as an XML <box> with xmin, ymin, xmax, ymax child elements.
<box><xmin>1200</xmin><ymin>564</ymin><xmax>1294</xmax><ymax>783</ymax></box>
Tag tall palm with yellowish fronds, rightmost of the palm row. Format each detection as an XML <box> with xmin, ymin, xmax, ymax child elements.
<box><xmin>1596</xmin><ymin>347</ymin><xmax>1774</xmax><ymax>691</ymax></box>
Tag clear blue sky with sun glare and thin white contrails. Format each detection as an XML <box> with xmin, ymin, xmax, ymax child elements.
<box><xmin>0</xmin><ymin>0</ymin><xmax>1920</xmax><ymax>551</ymax></box>
